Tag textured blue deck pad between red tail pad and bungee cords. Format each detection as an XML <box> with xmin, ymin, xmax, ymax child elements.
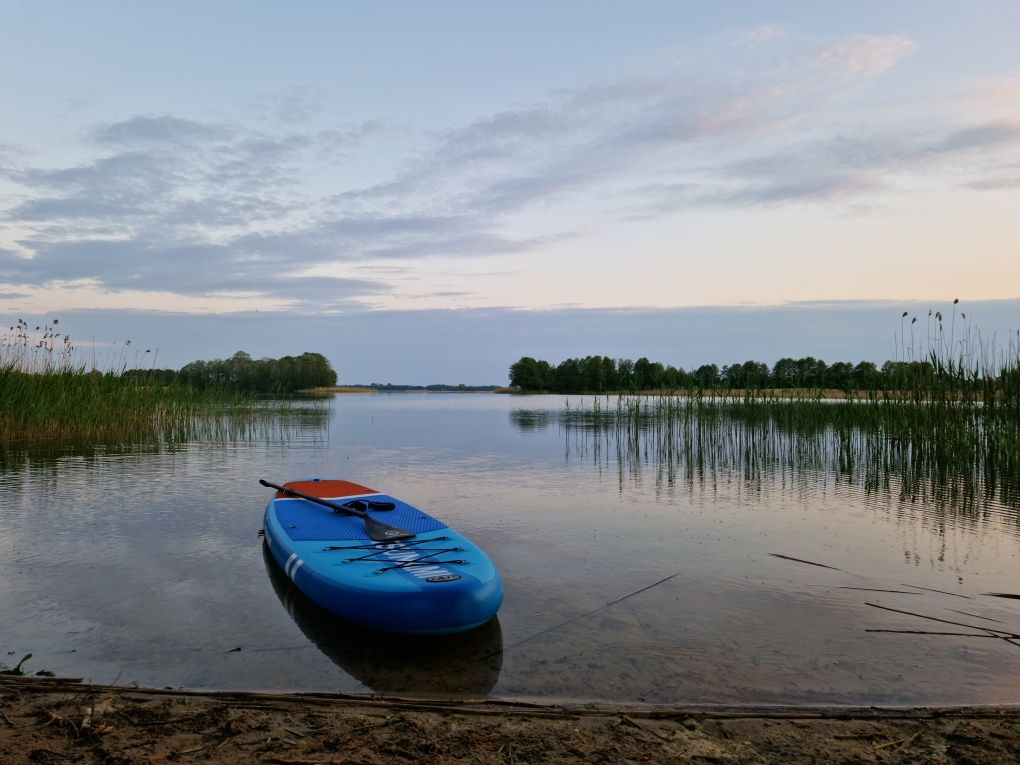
<box><xmin>275</xmin><ymin>494</ymin><xmax>447</xmax><ymax>542</ymax></box>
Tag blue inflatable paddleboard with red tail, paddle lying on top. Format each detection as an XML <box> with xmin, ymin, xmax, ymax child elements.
<box><xmin>262</xmin><ymin>478</ymin><xmax>503</xmax><ymax>634</ymax></box>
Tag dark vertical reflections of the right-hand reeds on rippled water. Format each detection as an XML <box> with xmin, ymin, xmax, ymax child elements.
<box><xmin>510</xmin><ymin>399</ymin><xmax>1020</xmax><ymax>525</ymax></box>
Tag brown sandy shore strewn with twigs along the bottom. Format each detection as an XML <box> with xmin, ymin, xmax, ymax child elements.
<box><xmin>0</xmin><ymin>676</ymin><xmax>1020</xmax><ymax>765</ymax></box>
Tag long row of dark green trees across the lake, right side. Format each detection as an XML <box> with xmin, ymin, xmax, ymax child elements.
<box><xmin>510</xmin><ymin>356</ymin><xmax>991</xmax><ymax>393</ymax></box>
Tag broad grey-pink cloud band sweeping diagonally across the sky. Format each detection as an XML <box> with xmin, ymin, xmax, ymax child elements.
<box><xmin>0</xmin><ymin>27</ymin><xmax>1018</xmax><ymax>314</ymax></box>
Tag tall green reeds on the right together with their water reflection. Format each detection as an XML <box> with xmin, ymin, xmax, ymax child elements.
<box><xmin>562</xmin><ymin>314</ymin><xmax>1020</xmax><ymax>518</ymax></box>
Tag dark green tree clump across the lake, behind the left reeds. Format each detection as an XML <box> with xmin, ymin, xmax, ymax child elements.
<box><xmin>123</xmin><ymin>351</ymin><xmax>337</xmax><ymax>393</ymax></box>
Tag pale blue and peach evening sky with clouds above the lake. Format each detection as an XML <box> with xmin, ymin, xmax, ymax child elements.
<box><xmin>0</xmin><ymin>0</ymin><xmax>1020</xmax><ymax>385</ymax></box>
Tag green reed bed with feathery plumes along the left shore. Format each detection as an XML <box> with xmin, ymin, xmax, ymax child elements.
<box><xmin>0</xmin><ymin>320</ymin><xmax>324</xmax><ymax>445</ymax></box>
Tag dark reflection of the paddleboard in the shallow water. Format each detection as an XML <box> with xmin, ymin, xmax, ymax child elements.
<box><xmin>262</xmin><ymin>544</ymin><xmax>503</xmax><ymax>697</ymax></box>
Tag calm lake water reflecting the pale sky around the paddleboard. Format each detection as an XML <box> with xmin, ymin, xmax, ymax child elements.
<box><xmin>0</xmin><ymin>394</ymin><xmax>1020</xmax><ymax>705</ymax></box>
